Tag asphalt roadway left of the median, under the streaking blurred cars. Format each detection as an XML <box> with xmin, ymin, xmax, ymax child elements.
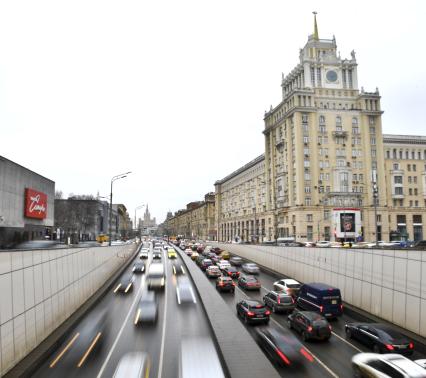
<box><xmin>32</xmin><ymin>242</ymin><xmax>218</xmax><ymax>378</ymax></box>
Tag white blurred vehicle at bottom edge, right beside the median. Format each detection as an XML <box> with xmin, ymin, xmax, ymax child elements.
<box><xmin>180</xmin><ymin>336</ymin><xmax>225</xmax><ymax>378</ymax></box>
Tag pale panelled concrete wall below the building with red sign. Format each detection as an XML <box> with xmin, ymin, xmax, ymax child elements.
<box><xmin>0</xmin><ymin>245</ymin><xmax>134</xmax><ymax>376</ymax></box>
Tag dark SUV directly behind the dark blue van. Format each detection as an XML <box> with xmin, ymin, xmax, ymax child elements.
<box><xmin>287</xmin><ymin>310</ymin><xmax>331</xmax><ymax>341</ymax></box>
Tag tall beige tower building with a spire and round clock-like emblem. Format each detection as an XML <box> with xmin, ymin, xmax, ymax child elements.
<box><xmin>263</xmin><ymin>14</ymin><xmax>389</xmax><ymax>241</ymax></box>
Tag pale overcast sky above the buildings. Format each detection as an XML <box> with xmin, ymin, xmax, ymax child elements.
<box><xmin>0</xmin><ymin>0</ymin><xmax>426</xmax><ymax>221</ymax></box>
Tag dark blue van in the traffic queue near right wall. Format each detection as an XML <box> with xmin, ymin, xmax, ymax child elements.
<box><xmin>297</xmin><ymin>282</ymin><xmax>343</xmax><ymax>318</ymax></box>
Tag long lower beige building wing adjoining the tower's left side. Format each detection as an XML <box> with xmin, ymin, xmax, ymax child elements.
<box><xmin>215</xmin><ymin>155</ymin><xmax>275</xmax><ymax>242</ymax></box>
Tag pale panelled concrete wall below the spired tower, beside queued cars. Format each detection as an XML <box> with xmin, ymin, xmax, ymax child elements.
<box><xmin>219</xmin><ymin>244</ymin><xmax>426</xmax><ymax>337</ymax></box>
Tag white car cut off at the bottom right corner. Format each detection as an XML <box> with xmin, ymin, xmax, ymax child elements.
<box><xmin>352</xmin><ymin>353</ymin><xmax>426</xmax><ymax>378</ymax></box>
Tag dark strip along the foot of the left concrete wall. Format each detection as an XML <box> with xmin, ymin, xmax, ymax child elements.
<box><xmin>4</xmin><ymin>243</ymin><xmax>142</xmax><ymax>378</ymax></box>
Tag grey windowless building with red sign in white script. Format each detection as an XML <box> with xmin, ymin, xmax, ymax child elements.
<box><xmin>0</xmin><ymin>156</ymin><xmax>55</xmax><ymax>248</ymax></box>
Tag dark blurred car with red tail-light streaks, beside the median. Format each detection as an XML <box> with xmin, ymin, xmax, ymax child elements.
<box><xmin>255</xmin><ymin>327</ymin><xmax>314</xmax><ymax>366</ymax></box>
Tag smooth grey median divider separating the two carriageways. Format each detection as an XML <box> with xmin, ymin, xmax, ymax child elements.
<box><xmin>175</xmin><ymin>247</ymin><xmax>279</xmax><ymax>378</ymax></box>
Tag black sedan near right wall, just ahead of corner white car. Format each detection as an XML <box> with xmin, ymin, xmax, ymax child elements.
<box><xmin>345</xmin><ymin>323</ymin><xmax>414</xmax><ymax>355</ymax></box>
